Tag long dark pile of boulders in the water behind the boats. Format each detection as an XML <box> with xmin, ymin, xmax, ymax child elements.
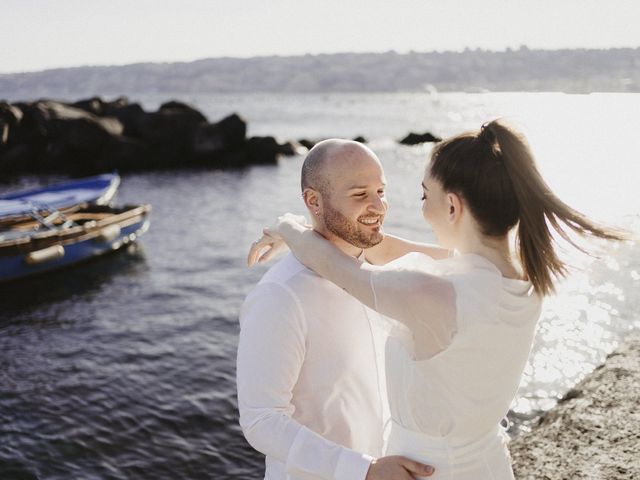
<box><xmin>0</xmin><ymin>97</ymin><xmax>291</xmax><ymax>175</ymax></box>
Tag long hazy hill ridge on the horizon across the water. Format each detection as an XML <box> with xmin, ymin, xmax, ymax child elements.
<box><xmin>0</xmin><ymin>47</ymin><xmax>640</xmax><ymax>100</ymax></box>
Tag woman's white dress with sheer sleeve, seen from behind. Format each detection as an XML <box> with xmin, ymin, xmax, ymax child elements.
<box><xmin>371</xmin><ymin>253</ymin><xmax>541</xmax><ymax>480</ymax></box>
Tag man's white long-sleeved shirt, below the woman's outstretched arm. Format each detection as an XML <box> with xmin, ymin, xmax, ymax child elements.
<box><xmin>237</xmin><ymin>254</ymin><xmax>388</xmax><ymax>480</ymax></box>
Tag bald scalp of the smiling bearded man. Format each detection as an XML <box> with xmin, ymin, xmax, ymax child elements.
<box><xmin>300</xmin><ymin>138</ymin><xmax>376</xmax><ymax>196</ymax></box>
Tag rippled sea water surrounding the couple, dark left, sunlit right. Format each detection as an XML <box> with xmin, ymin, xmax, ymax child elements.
<box><xmin>0</xmin><ymin>94</ymin><xmax>640</xmax><ymax>479</ymax></box>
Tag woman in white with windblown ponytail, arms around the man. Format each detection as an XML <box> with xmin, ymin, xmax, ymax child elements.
<box><xmin>250</xmin><ymin>120</ymin><xmax>621</xmax><ymax>480</ymax></box>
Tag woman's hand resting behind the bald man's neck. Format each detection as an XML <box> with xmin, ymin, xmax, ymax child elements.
<box><xmin>247</xmin><ymin>213</ymin><xmax>311</xmax><ymax>267</ymax></box>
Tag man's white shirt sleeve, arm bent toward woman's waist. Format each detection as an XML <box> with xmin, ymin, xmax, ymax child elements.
<box><xmin>237</xmin><ymin>283</ymin><xmax>373</xmax><ymax>480</ymax></box>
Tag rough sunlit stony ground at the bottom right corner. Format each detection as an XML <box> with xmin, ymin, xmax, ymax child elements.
<box><xmin>510</xmin><ymin>334</ymin><xmax>640</xmax><ymax>480</ymax></box>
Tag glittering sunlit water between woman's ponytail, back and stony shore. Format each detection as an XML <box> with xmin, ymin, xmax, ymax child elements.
<box><xmin>513</xmin><ymin>232</ymin><xmax>640</xmax><ymax>413</ymax></box>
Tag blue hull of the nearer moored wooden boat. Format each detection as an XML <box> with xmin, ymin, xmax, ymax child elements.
<box><xmin>0</xmin><ymin>206</ymin><xmax>149</xmax><ymax>282</ymax></box>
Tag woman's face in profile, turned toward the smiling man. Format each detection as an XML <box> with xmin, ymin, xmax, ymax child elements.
<box><xmin>422</xmin><ymin>167</ymin><xmax>455</xmax><ymax>249</ymax></box>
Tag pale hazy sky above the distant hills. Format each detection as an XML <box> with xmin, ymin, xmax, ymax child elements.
<box><xmin>5</xmin><ymin>0</ymin><xmax>640</xmax><ymax>73</ymax></box>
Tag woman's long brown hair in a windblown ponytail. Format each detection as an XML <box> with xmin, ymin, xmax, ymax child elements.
<box><xmin>430</xmin><ymin>119</ymin><xmax>624</xmax><ymax>295</ymax></box>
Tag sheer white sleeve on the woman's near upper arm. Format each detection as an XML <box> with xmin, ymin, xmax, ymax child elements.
<box><xmin>370</xmin><ymin>253</ymin><xmax>458</xmax><ymax>360</ymax></box>
